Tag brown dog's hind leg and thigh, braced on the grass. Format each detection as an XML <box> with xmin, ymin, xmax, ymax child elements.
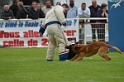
<box><xmin>98</xmin><ymin>47</ymin><xmax>111</xmax><ymax>60</ymax></box>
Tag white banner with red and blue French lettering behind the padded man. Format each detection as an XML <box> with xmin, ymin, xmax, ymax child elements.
<box><xmin>0</xmin><ymin>19</ymin><xmax>79</xmax><ymax>47</ymax></box>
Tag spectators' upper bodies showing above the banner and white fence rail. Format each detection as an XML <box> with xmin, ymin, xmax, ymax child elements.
<box><xmin>0</xmin><ymin>0</ymin><xmax>108</xmax><ymax>19</ymax></box>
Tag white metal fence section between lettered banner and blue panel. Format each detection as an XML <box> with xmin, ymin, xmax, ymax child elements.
<box><xmin>78</xmin><ymin>18</ymin><xmax>109</xmax><ymax>44</ymax></box>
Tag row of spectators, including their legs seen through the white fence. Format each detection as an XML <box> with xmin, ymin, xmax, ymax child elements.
<box><xmin>0</xmin><ymin>0</ymin><xmax>108</xmax><ymax>42</ymax></box>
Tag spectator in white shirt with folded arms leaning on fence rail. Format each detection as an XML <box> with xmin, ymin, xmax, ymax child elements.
<box><xmin>78</xmin><ymin>3</ymin><xmax>90</xmax><ymax>17</ymax></box>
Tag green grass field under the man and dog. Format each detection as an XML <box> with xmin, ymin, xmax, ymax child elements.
<box><xmin>0</xmin><ymin>48</ymin><xmax>124</xmax><ymax>82</ymax></box>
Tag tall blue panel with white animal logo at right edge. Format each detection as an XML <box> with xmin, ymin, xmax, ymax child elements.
<box><xmin>108</xmin><ymin>0</ymin><xmax>124</xmax><ymax>51</ymax></box>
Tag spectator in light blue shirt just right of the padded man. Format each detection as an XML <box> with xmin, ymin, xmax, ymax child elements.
<box><xmin>67</xmin><ymin>0</ymin><xmax>78</xmax><ymax>18</ymax></box>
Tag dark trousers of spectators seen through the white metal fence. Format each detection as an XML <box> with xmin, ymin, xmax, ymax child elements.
<box><xmin>91</xmin><ymin>24</ymin><xmax>105</xmax><ymax>42</ymax></box>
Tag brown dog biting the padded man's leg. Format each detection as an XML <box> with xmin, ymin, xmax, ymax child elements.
<box><xmin>71</xmin><ymin>42</ymin><xmax>121</xmax><ymax>61</ymax></box>
